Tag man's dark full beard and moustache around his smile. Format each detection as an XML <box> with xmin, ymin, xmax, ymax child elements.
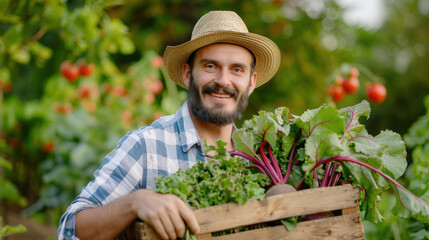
<box><xmin>188</xmin><ymin>74</ymin><xmax>250</xmax><ymax>126</ymax></box>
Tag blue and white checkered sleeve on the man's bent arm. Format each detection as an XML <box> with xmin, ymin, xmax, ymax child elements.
<box><xmin>57</xmin><ymin>131</ymin><xmax>146</xmax><ymax>240</ymax></box>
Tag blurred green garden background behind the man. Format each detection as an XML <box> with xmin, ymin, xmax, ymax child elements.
<box><xmin>0</xmin><ymin>0</ymin><xmax>429</xmax><ymax>239</ymax></box>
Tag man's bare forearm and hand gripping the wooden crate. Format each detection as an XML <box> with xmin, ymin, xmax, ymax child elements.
<box><xmin>75</xmin><ymin>189</ymin><xmax>200</xmax><ymax>240</ymax></box>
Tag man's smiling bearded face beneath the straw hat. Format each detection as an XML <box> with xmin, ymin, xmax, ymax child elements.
<box><xmin>184</xmin><ymin>44</ymin><xmax>256</xmax><ymax>126</ymax></box>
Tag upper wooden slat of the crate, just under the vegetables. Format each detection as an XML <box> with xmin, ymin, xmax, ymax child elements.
<box><xmin>194</xmin><ymin>184</ymin><xmax>359</xmax><ymax>233</ymax></box>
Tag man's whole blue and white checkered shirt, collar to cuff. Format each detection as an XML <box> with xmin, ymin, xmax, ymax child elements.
<box><xmin>58</xmin><ymin>101</ymin><xmax>205</xmax><ymax>240</ymax></box>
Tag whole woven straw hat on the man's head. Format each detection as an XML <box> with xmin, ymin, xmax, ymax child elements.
<box><xmin>164</xmin><ymin>11</ymin><xmax>280</xmax><ymax>87</ymax></box>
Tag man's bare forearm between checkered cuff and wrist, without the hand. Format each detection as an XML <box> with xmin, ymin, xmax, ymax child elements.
<box><xmin>75</xmin><ymin>190</ymin><xmax>149</xmax><ymax>240</ymax></box>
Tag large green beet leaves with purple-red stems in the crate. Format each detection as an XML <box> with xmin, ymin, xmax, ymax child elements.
<box><xmin>231</xmin><ymin>100</ymin><xmax>429</xmax><ymax>223</ymax></box>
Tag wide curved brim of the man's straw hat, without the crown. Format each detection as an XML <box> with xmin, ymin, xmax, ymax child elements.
<box><xmin>164</xmin><ymin>31</ymin><xmax>281</xmax><ymax>88</ymax></box>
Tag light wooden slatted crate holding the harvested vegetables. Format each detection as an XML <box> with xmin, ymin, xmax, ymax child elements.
<box><xmin>120</xmin><ymin>184</ymin><xmax>365</xmax><ymax>240</ymax></box>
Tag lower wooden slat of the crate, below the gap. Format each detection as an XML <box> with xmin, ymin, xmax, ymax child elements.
<box><xmin>209</xmin><ymin>213</ymin><xmax>365</xmax><ymax>240</ymax></box>
